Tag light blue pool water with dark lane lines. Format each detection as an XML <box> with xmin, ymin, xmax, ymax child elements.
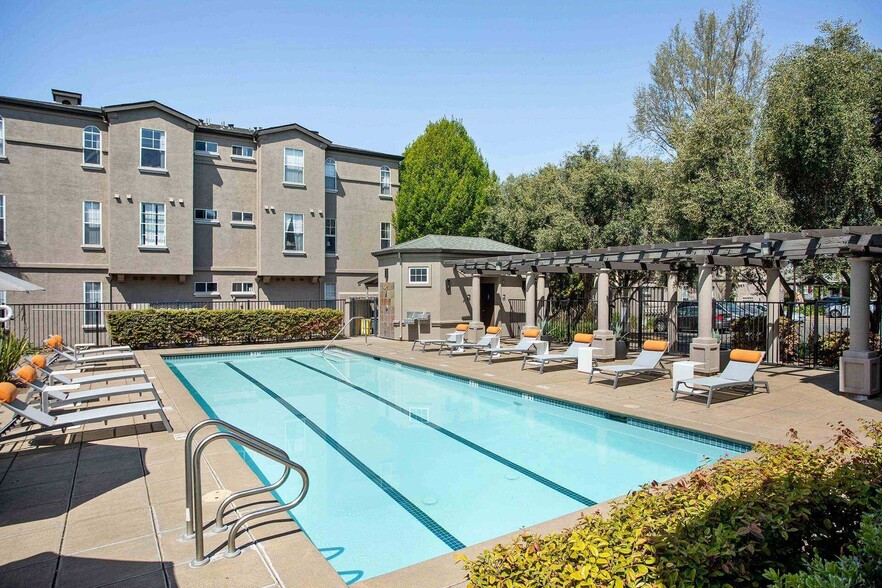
<box><xmin>165</xmin><ymin>350</ymin><xmax>747</xmax><ymax>582</ymax></box>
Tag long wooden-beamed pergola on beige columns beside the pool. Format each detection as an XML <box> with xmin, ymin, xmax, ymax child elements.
<box><xmin>444</xmin><ymin>226</ymin><xmax>882</xmax><ymax>398</ymax></box>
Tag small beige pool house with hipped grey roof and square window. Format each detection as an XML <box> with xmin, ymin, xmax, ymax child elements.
<box><xmin>373</xmin><ymin>235</ymin><xmax>529</xmax><ymax>341</ymax></box>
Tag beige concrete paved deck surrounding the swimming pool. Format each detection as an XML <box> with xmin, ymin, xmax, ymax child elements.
<box><xmin>0</xmin><ymin>339</ymin><xmax>882</xmax><ymax>588</ymax></box>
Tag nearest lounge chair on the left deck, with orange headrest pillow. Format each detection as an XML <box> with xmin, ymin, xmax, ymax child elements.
<box><xmin>0</xmin><ymin>382</ymin><xmax>173</xmax><ymax>441</ymax></box>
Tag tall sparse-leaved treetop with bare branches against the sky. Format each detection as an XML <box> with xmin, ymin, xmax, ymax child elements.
<box><xmin>632</xmin><ymin>0</ymin><xmax>765</xmax><ymax>155</ymax></box>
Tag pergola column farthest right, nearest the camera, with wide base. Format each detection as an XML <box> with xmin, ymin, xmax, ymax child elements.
<box><xmin>839</xmin><ymin>257</ymin><xmax>879</xmax><ymax>400</ymax></box>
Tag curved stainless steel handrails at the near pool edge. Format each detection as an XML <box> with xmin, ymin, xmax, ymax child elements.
<box><xmin>183</xmin><ymin>419</ymin><xmax>309</xmax><ymax>567</ymax></box>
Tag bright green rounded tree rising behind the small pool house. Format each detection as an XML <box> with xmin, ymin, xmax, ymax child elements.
<box><xmin>392</xmin><ymin>118</ymin><xmax>497</xmax><ymax>242</ymax></box>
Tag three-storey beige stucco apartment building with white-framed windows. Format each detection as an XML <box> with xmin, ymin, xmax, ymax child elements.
<box><xmin>0</xmin><ymin>90</ymin><xmax>401</xmax><ymax>303</ymax></box>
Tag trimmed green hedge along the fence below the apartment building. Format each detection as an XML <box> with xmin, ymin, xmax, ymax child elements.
<box><xmin>107</xmin><ymin>308</ymin><xmax>343</xmax><ymax>349</ymax></box>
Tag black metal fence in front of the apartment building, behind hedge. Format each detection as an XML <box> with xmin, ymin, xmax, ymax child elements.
<box><xmin>6</xmin><ymin>299</ymin><xmax>346</xmax><ymax>345</ymax></box>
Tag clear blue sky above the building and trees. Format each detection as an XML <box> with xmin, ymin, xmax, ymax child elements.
<box><xmin>0</xmin><ymin>0</ymin><xmax>882</xmax><ymax>176</ymax></box>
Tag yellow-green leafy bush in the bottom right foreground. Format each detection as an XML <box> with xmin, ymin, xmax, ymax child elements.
<box><xmin>460</xmin><ymin>424</ymin><xmax>882</xmax><ymax>587</ymax></box>
